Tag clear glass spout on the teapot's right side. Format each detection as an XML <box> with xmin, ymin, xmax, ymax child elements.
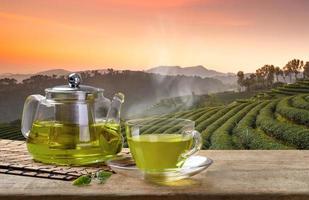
<box><xmin>106</xmin><ymin>92</ymin><xmax>124</xmax><ymax>123</ymax></box>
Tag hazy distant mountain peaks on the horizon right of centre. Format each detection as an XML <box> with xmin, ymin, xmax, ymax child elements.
<box><xmin>146</xmin><ymin>65</ymin><xmax>232</xmax><ymax>78</ymax></box>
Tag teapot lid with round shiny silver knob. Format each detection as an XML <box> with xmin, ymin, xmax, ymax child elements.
<box><xmin>45</xmin><ymin>73</ymin><xmax>104</xmax><ymax>100</ymax></box>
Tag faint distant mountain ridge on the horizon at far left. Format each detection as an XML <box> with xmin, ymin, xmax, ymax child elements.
<box><xmin>0</xmin><ymin>69</ymin><xmax>70</xmax><ymax>82</ymax></box>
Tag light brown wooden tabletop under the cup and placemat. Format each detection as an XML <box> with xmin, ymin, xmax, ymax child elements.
<box><xmin>0</xmin><ymin>150</ymin><xmax>309</xmax><ymax>200</ymax></box>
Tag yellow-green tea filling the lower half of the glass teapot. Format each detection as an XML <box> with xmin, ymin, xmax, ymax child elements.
<box><xmin>27</xmin><ymin>121</ymin><xmax>122</xmax><ymax>165</ymax></box>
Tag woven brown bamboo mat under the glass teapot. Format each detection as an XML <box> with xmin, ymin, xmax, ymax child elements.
<box><xmin>0</xmin><ymin>139</ymin><xmax>119</xmax><ymax>181</ymax></box>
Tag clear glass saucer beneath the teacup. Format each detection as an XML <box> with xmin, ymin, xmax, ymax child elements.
<box><xmin>106</xmin><ymin>155</ymin><xmax>213</xmax><ymax>183</ymax></box>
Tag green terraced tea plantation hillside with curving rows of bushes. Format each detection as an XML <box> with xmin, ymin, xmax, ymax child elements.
<box><xmin>131</xmin><ymin>80</ymin><xmax>309</xmax><ymax>149</ymax></box>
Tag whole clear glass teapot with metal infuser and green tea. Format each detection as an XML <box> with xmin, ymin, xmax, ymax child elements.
<box><xmin>21</xmin><ymin>73</ymin><xmax>124</xmax><ymax>165</ymax></box>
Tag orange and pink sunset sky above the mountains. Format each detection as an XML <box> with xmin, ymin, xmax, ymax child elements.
<box><xmin>0</xmin><ymin>0</ymin><xmax>309</xmax><ymax>73</ymax></box>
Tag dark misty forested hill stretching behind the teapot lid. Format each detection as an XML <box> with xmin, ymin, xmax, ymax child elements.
<box><xmin>0</xmin><ymin>69</ymin><xmax>228</xmax><ymax>123</ymax></box>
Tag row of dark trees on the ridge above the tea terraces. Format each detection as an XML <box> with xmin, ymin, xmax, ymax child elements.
<box><xmin>237</xmin><ymin>59</ymin><xmax>309</xmax><ymax>91</ymax></box>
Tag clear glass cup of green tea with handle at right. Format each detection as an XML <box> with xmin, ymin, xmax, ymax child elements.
<box><xmin>126</xmin><ymin>118</ymin><xmax>202</xmax><ymax>172</ymax></box>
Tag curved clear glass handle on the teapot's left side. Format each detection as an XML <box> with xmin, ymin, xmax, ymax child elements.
<box><xmin>21</xmin><ymin>94</ymin><xmax>45</xmax><ymax>138</ymax></box>
